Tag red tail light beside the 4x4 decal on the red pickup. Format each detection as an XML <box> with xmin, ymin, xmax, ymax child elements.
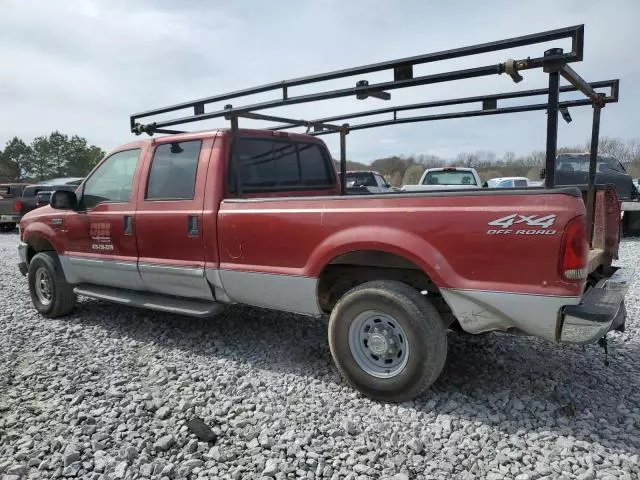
<box><xmin>559</xmin><ymin>215</ymin><xmax>589</xmax><ymax>280</ymax></box>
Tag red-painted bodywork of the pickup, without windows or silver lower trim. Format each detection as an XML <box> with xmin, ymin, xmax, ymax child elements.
<box><xmin>21</xmin><ymin>130</ymin><xmax>619</xmax><ymax>302</ymax></box>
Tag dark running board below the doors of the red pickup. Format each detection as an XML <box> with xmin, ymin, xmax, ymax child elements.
<box><xmin>73</xmin><ymin>284</ymin><xmax>222</xmax><ymax>318</ymax></box>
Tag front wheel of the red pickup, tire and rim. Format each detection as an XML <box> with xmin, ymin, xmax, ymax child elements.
<box><xmin>27</xmin><ymin>252</ymin><xmax>78</xmax><ymax>318</ymax></box>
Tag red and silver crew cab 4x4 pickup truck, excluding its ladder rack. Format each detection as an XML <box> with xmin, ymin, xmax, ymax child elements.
<box><xmin>19</xmin><ymin>129</ymin><xmax>628</xmax><ymax>401</ymax></box>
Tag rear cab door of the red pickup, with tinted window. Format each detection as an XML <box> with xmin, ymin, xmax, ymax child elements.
<box><xmin>135</xmin><ymin>138</ymin><xmax>214</xmax><ymax>300</ymax></box>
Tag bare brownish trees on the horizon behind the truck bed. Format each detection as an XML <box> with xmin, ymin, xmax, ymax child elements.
<box><xmin>347</xmin><ymin>137</ymin><xmax>640</xmax><ymax>187</ymax></box>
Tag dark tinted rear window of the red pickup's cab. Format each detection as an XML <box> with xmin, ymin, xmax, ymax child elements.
<box><xmin>227</xmin><ymin>137</ymin><xmax>337</xmax><ymax>194</ymax></box>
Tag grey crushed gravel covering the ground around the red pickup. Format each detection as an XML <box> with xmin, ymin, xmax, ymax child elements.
<box><xmin>0</xmin><ymin>234</ymin><xmax>640</xmax><ymax>480</ymax></box>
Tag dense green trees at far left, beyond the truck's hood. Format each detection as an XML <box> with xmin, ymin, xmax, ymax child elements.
<box><xmin>0</xmin><ymin>130</ymin><xmax>105</xmax><ymax>182</ymax></box>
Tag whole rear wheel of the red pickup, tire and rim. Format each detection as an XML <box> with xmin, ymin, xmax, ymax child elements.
<box><xmin>329</xmin><ymin>280</ymin><xmax>447</xmax><ymax>402</ymax></box>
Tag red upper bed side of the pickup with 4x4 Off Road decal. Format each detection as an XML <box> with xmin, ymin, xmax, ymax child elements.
<box><xmin>218</xmin><ymin>191</ymin><xmax>585</xmax><ymax>295</ymax></box>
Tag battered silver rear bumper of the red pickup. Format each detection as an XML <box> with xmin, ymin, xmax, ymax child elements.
<box><xmin>560</xmin><ymin>268</ymin><xmax>634</xmax><ymax>345</ymax></box>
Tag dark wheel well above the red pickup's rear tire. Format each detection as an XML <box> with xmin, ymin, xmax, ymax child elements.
<box><xmin>318</xmin><ymin>250</ymin><xmax>454</xmax><ymax>324</ymax></box>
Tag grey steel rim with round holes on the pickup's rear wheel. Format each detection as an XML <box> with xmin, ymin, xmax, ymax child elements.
<box><xmin>349</xmin><ymin>310</ymin><xmax>409</xmax><ymax>378</ymax></box>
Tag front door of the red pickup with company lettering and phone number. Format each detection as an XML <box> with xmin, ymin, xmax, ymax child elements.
<box><xmin>61</xmin><ymin>148</ymin><xmax>146</xmax><ymax>290</ymax></box>
